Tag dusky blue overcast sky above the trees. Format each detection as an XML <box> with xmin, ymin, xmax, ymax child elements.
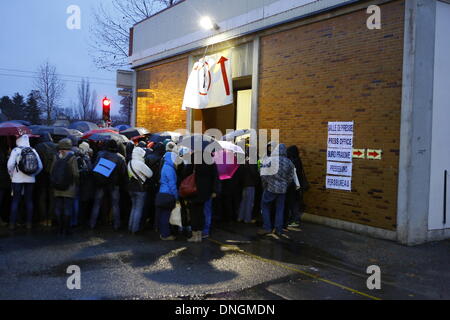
<box><xmin>0</xmin><ymin>0</ymin><xmax>129</xmax><ymax>113</ymax></box>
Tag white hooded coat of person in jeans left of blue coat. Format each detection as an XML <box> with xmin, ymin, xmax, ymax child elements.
<box><xmin>128</xmin><ymin>148</ymin><xmax>153</xmax><ymax>192</ymax></box>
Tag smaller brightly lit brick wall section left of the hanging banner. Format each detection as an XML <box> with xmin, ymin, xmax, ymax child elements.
<box><xmin>136</xmin><ymin>58</ymin><xmax>188</xmax><ymax>132</ymax></box>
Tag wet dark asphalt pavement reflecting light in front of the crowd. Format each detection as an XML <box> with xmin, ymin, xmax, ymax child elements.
<box><xmin>0</xmin><ymin>223</ymin><xmax>450</xmax><ymax>300</ymax></box>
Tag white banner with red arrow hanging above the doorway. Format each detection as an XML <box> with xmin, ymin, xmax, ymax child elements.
<box><xmin>182</xmin><ymin>50</ymin><xmax>233</xmax><ymax>110</ymax></box>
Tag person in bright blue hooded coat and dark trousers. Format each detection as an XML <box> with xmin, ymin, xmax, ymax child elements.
<box><xmin>155</xmin><ymin>142</ymin><xmax>178</xmax><ymax>240</ymax></box>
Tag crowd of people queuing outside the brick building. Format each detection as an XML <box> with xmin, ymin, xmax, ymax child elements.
<box><xmin>0</xmin><ymin>134</ymin><xmax>308</xmax><ymax>242</ymax></box>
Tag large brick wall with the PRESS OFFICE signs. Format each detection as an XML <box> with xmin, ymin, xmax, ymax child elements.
<box><xmin>259</xmin><ymin>1</ymin><xmax>404</xmax><ymax>230</ymax></box>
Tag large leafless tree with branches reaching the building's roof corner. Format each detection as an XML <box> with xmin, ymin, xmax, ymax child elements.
<box><xmin>90</xmin><ymin>0</ymin><xmax>181</xmax><ymax>70</ymax></box>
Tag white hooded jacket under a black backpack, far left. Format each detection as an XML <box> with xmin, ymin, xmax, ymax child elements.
<box><xmin>8</xmin><ymin>135</ymin><xmax>43</xmax><ymax>183</ymax></box>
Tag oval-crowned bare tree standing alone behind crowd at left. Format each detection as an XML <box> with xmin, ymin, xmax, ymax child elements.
<box><xmin>35</xmin><ymin>61</ymin><xmax>64</xmax><ymax>124</ymax></box>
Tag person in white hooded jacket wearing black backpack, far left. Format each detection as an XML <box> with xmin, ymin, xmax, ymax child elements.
<box><xmin>7</xmin><ymin>135</ymin><xmax>43</xmax><ymax>230</ymax></box>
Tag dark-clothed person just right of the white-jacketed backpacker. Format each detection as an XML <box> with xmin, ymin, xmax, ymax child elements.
<box><xmin>35</xmin><ymin>132</ymin><xmax>58</xmax><ymax>227</ymax></box>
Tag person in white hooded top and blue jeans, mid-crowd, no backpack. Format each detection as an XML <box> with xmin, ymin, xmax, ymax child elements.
<box><xmin>128</xmin><ymin>147</ymin><xmax>153</xmax><ymax>234</ymax></box>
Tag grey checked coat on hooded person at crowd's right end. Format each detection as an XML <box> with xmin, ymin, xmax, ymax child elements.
<box><xmin>261</xmin><ymin>144</ymin><xmax>295</xmax><ymax>194</ymax></box>
